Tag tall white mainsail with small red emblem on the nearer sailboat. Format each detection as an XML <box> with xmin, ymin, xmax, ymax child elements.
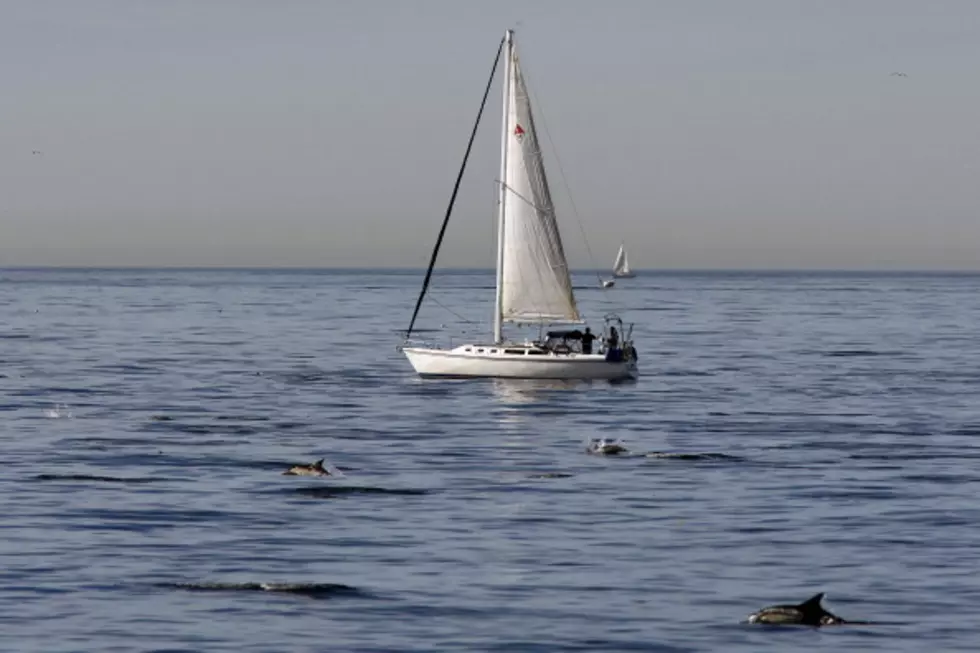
<box><xmin>500</xmin><ymin>48</ymin><xmax>581</xmax><ymax>323</ymax></box>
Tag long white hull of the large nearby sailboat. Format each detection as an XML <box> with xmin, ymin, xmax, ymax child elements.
<box><xmin>403</xmin><ymin>345</ymin><xmax>638</xmax><ymax>380</ymax></box>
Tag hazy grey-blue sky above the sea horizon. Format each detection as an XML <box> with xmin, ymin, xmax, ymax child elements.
<box><xmin>0</xmin><ymin>0</ymin><xmax>980</xmax><ymax>269</ymax></box>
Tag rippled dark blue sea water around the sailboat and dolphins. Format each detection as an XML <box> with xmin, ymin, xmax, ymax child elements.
<box><xmin>0</xmin><ymin>271</ymin><xmax>980</xmax><ymax>653</ymax></box>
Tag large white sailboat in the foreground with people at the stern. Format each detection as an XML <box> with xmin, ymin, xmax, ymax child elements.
<box><xmin>400</xmin><ymin>30</ymin><xmax>638</xmax><ymax>379</ymax></box>
